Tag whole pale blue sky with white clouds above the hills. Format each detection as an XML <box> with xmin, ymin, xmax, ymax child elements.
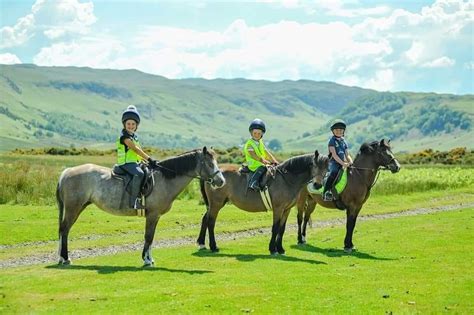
<box><xmin>0</xmin><ymin>0</ymin><xmax>474</xmax><ymax>94</ymax></box>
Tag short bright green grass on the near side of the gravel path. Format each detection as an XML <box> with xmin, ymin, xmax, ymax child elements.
<box><xmin>0</xmin><ymin>208</ymin><xmax>474</xmax><ymax>314</ymax></box>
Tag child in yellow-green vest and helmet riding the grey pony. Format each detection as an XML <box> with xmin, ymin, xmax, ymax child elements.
<box><xmin>116</xmin><ymin>105</ymin><xmax>158</xmax><ymax>209</ymax></box>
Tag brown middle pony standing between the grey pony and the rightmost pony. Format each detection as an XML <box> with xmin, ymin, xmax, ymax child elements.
<box><xmin>197</xmin><ymin>151</ymin><xmax>328</xmax><ymax>255</ymax></box>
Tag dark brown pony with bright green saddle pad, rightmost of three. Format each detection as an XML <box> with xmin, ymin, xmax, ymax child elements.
<box><xmin>296</xmin><ymin>139</ymin><xmax>400</xmax><ymax>253</ymax></box>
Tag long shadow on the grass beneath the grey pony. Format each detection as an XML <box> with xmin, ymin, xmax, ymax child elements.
<box><xmin>46</xmin><ymin>265</ymin><xmax>214</xmax><ymax>275</ymax></box>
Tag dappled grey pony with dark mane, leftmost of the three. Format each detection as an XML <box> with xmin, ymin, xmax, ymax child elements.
<box><xmin>56</xmin><ymin>147</ymin><xmax>225</xmax><ymax>266</ymax></box>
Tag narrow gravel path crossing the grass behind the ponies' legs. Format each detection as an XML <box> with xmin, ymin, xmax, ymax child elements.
<box><xmin>0</xmin><ymin>203</ymin><xmax>474</xmax><ymax>269</ymax></box>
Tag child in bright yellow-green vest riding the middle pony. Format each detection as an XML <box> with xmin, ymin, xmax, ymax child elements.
<box><xmin>244</xmin><ymin>118</ymin><xmax>278</xmax><ymax>191</ymax></box>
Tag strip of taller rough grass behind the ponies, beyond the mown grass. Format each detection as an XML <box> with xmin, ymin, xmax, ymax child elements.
<box><xmin>0</xmin><ymin>156</ymin><xmax>474</xmax><ymax>205</ymax></box>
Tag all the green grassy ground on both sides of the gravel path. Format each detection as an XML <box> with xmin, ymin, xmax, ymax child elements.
<box><xmin>0</xmin><ymin>155</ymin><xmax>474</xmax><ymax>314</ymax></box>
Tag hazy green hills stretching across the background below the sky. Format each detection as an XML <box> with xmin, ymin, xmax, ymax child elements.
<box><xmin>0</xmin><ymin>65</ymin><xmax>474</xmax><ymax>151</ymax></box>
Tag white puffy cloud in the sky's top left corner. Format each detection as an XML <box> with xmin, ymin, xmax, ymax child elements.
<box><xmin>0</xmin><ymin>0</ymin><xmax>97</xmax><ymax>49</ymax></box>
